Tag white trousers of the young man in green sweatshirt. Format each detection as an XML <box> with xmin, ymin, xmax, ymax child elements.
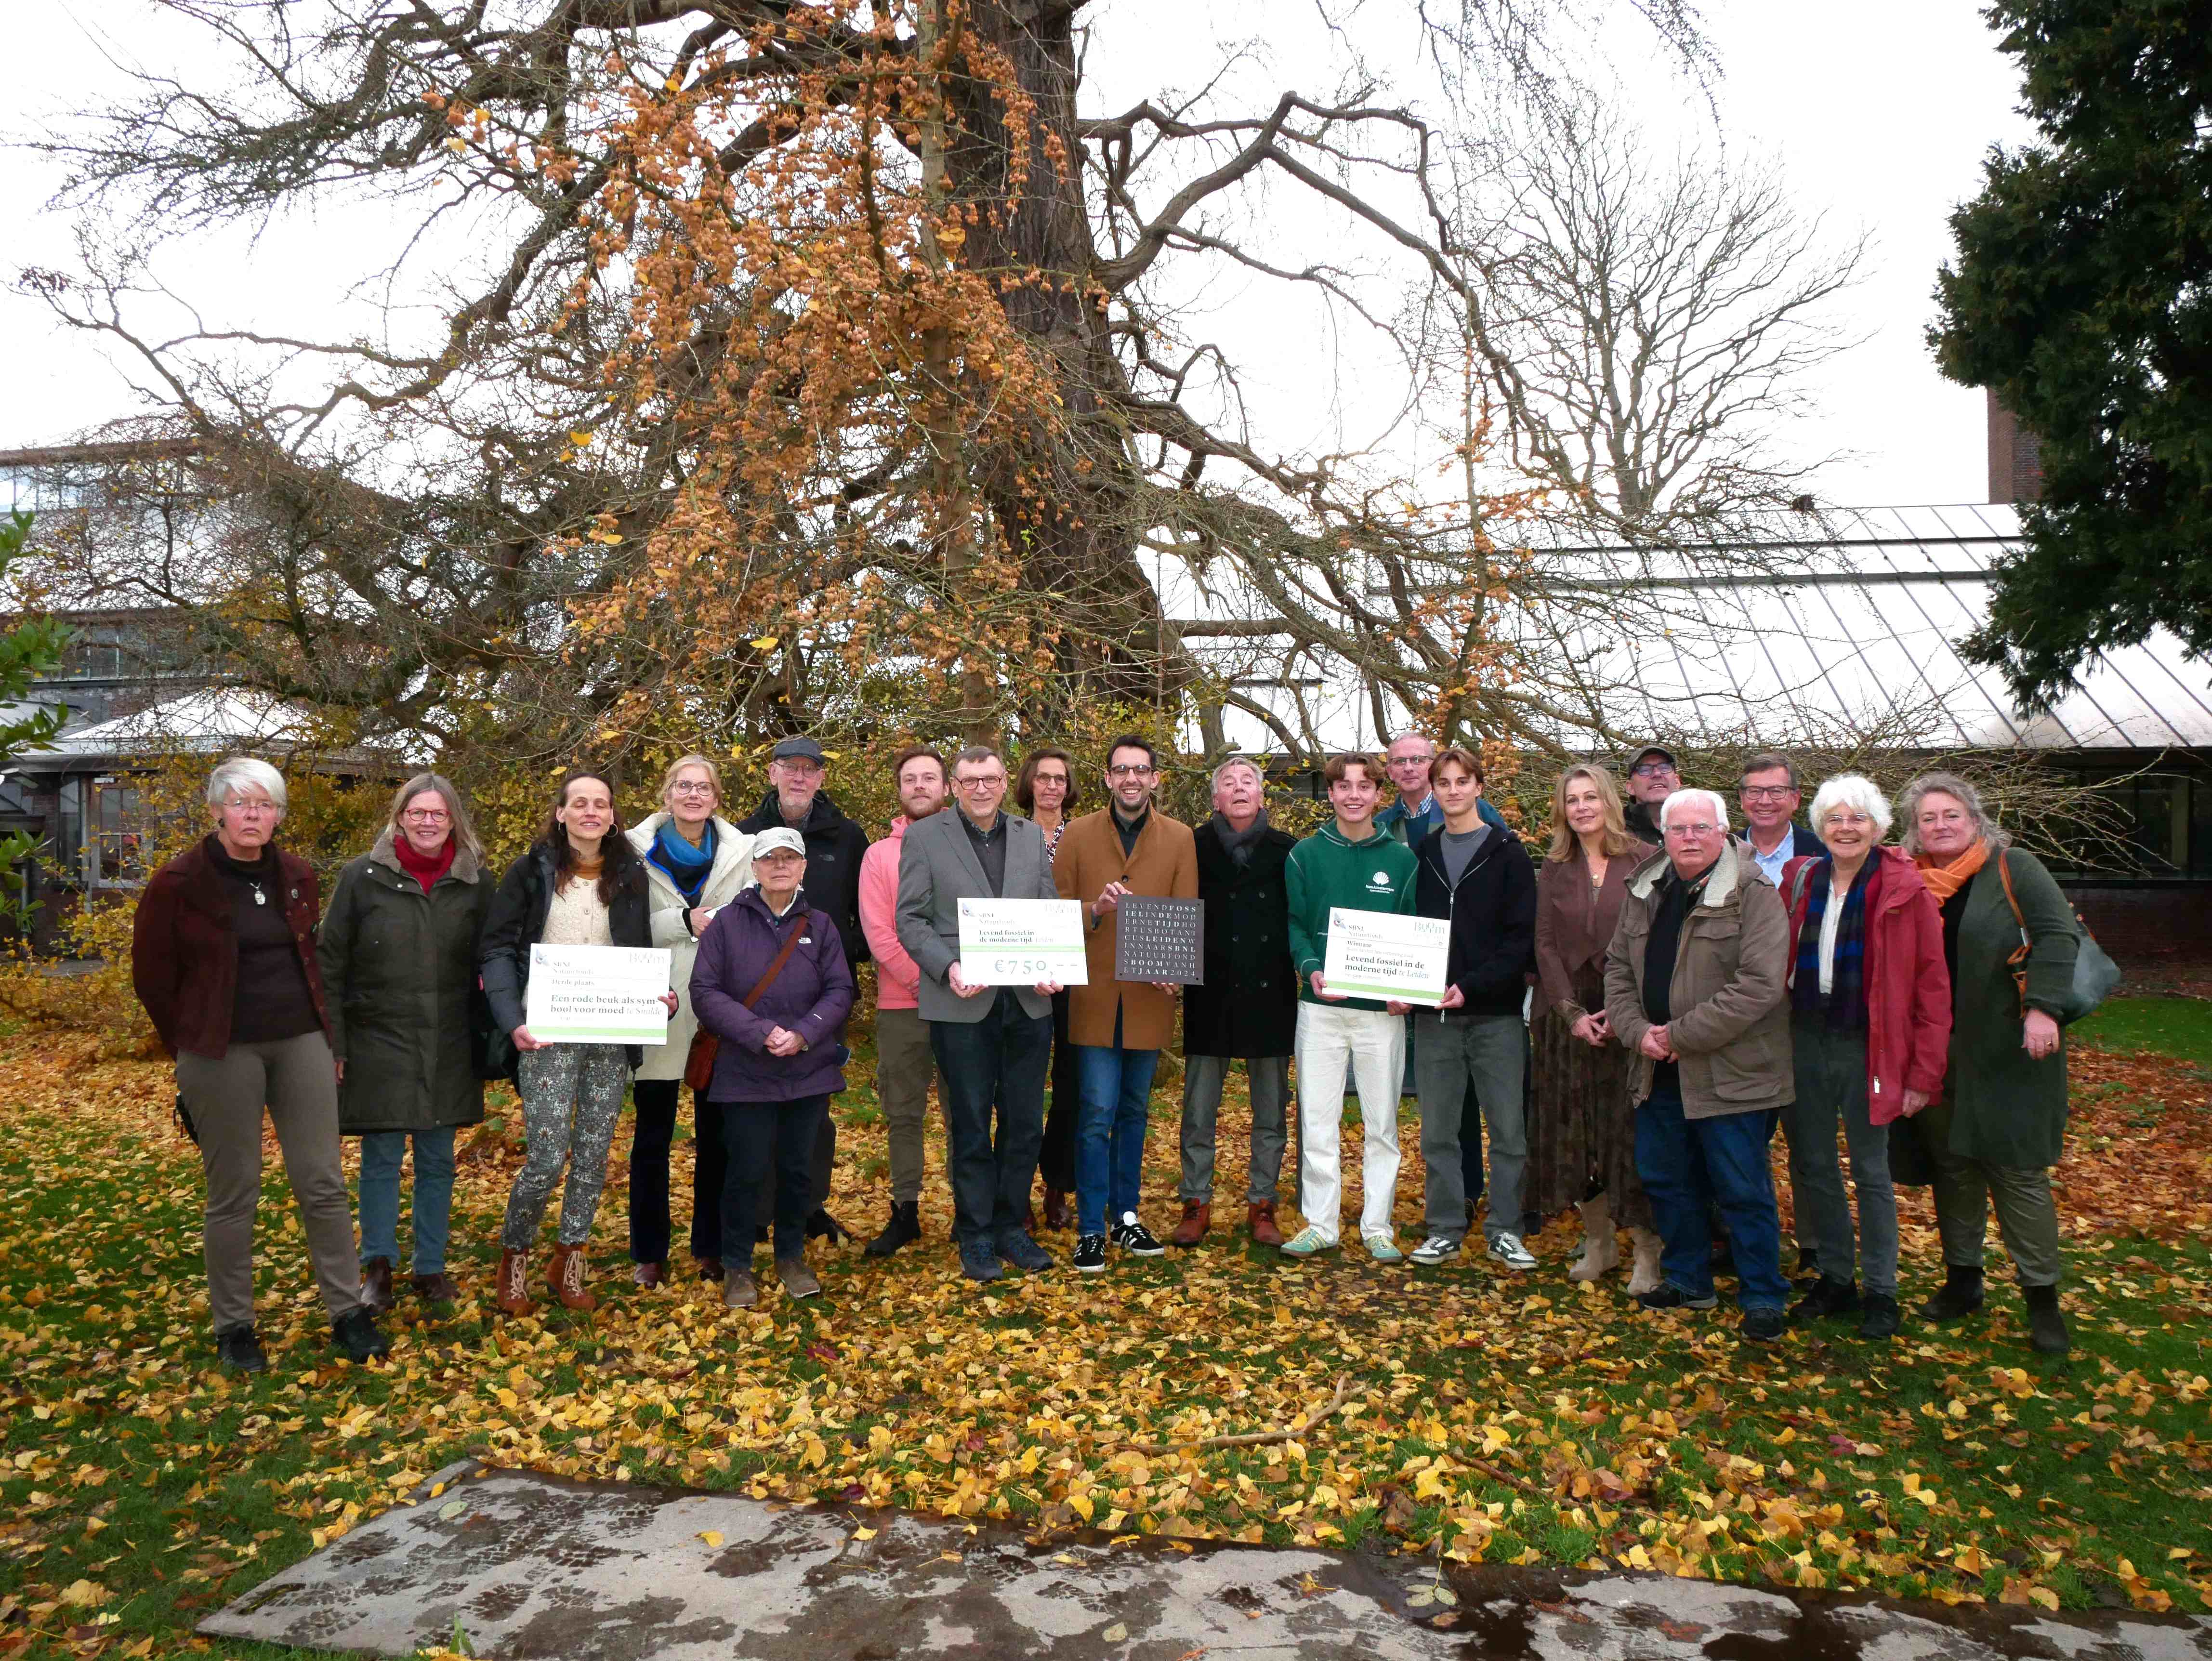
<box><xmin>1299</xmin><ymin>1002</ymin><xmax>1405</xmax><ymax>1245</ymax></box>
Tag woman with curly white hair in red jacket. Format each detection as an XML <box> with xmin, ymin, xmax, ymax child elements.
<box><xmin>1783</xmin><ymin>772</ymin><xmax>1951</xmax><ymax>1338</ymax></box>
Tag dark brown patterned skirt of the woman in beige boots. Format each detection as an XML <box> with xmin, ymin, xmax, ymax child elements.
<box><xmin>1522</xmin><ymin>966</ymin><xmax>1652</xmax><ymax>1227</ymax></box>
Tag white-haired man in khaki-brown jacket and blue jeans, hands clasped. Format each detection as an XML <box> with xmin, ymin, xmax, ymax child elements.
<box><xmin>1606</xmin><ymin>790</ymin><xmax>1796</xmax><ymax>1343</ymax></box>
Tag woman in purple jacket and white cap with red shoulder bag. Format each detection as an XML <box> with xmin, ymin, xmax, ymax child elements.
<box><xmin>692</xmin><ymin>825</ymin><xmax>854</xmax><ymax>1309</ymax></box>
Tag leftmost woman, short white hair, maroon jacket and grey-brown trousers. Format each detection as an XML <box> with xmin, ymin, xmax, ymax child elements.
<box><xmin>131</xmin><ymin>756</ymin><xmax>389</xmax><ymax>1373</ymax></box>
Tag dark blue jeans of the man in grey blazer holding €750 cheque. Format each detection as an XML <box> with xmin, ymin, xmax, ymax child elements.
<box><xmin>929</xmin><ymin>987</ymin><xmax>1053</xmax><ymax>1247</ymax></box>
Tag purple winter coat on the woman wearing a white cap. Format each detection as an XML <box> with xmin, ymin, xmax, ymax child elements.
<box><xmin>692</xmin><ymin>884</ymin><xmax>854</xmax><ymax>1101</ymax></box>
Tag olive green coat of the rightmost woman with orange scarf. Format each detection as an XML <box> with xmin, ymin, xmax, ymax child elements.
<box><xmin>1944</xmin><ymin>847</ymin><xmax>2081</xmax><ymax>1168</ymax></box>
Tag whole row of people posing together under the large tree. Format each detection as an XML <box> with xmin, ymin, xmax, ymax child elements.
<box><xmin>133</xmin><ymin>734</ymin><xmax>2079</xmax><ymax>1369</ymax></box>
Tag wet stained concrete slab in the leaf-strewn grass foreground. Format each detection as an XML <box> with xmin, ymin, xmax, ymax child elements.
<box><xmin>199</xmin><ymin>1462</ymin><xmax>2212</xmax><ymax>1661</ymax></box>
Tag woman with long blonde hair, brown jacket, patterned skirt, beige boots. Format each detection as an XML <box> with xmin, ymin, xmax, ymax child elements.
<box><xmin>1522</xmin><ymin>765</ymin><xmax>1659</xmax><ymax>1292</ymax></box>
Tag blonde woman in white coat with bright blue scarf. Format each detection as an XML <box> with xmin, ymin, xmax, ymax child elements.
<box><xmin>631</xmin><ymin>756</ymin><xmax>752</xmax><ymax>1287</ymax></box>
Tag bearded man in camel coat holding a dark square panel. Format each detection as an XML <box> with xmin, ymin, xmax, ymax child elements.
<box><xmin>1053</xmin><ymin>732</ymin><xmax>1199</xmax><ymax>1274</ymax></box>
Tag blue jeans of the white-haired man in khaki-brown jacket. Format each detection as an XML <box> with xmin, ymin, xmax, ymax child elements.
<box><xmin>1637</xmin><ymin>1086</ymin><xmax>1790</xmax><ymax>1309</ymax></box>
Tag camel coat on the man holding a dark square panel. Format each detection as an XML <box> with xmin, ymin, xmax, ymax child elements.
<box><xmin>1053</xmin><ymin>805</ymin><xmax>1199</xmax><ymax>1051</ymax></box>
